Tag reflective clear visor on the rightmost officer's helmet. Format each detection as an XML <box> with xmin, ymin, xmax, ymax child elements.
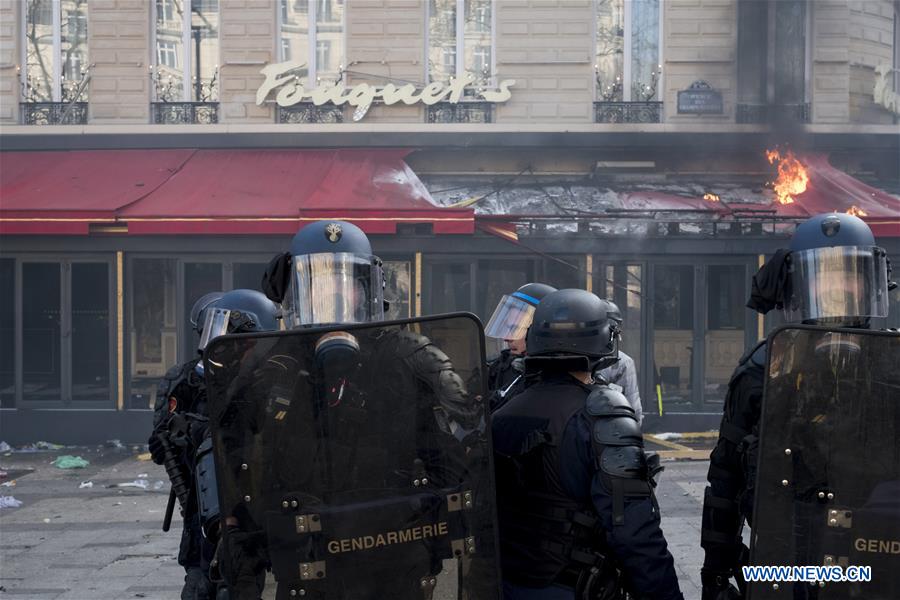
<box><xmin>784</xmin><ymin>246</ymin><xmax>888</xmax><ymax>323</ymax></box>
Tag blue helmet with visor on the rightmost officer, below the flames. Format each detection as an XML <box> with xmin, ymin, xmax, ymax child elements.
<box><xmin>784</xmin><ymin>213</ymin><xmax>889</xmax><ymax>325</ymax></box>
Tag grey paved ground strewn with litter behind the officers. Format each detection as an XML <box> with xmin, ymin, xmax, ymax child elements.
<box><xmin>0</xmin><ymin>436</ymin><xmax>709</xmax><ymax>600</ymax></box>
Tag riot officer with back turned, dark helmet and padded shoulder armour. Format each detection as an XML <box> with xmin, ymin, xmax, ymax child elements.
<box><xmin>492</xmin><ymin>289</ymin><xmax>682</xmax><ymax>600</ymax></box>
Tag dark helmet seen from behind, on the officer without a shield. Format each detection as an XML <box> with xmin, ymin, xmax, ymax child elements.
<box><xmin>526</xmin><ymin>289</ymin><xmax>621</xmax><ymax>370</ymax></box>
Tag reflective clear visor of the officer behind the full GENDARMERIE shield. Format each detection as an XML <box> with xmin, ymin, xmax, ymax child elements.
<box><xmin>282</xmin><ymin>253</ymin><xmax>384</xmax><ymax>328</ymax></box>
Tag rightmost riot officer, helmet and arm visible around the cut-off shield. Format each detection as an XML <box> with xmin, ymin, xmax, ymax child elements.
<box><xmin>700</xmin><ymin>213</ymin><xmax>891</xmax><ymax>600</ymax></box>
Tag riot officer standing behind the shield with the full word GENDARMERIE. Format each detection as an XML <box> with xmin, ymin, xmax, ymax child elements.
<box><xmin>211</xmin><ymin>221</ymin><xmax>488</xmax><ymax>599</ymax></box>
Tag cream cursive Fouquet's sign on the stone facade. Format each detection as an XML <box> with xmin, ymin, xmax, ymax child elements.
<box><xmin>256</xmin><ymin>61</ymin><xmax>516</xmax><ymax>121</ymax></box>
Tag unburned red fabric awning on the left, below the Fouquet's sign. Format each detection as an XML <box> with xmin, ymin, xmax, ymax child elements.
<box><xmin>0</xmin><ymin>149</ymin><xmax>474</xmax><ymax>234</ymax></box>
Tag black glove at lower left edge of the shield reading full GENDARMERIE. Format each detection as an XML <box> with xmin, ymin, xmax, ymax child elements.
<box><xmin>216</xmin><ymin>525</ymin><xmax>266</xmax><ymax>600</ymax></box>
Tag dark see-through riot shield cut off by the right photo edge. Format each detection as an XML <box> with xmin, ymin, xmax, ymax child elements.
<box><xmin>750</xmin><ymin>326</ymin><xmax>900</xmax><ymax>600</ymax></box>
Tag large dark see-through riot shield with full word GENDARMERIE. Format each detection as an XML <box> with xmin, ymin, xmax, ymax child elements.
<box><xmin>205</xmin><ymin>313</ymin><xmax>500</xmax><ymax>600</ymax></box>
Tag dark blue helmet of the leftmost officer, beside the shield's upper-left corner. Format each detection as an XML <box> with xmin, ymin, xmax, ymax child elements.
<box><xmin>198</xmin><ymin>289</ymin><xmax>281</xmax><ymax>351</ymax></box>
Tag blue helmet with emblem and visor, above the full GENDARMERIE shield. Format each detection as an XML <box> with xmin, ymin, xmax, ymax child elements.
<box><xmin>282</xmin><ymin>221</ymin><xmax>385</xmax><ymax>328</ymax></box>
